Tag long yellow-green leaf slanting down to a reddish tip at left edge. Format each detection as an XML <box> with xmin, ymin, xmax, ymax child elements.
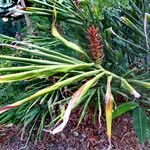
<box><xmin>0</xmin><ymin>70</ymin><xmax>100</xmax><ymax>114</ymax></box>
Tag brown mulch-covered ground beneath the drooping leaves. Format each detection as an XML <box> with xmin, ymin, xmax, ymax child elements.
<box><xmin>0</xmin><ymin>109</ymin><xmax>150</xmax><ymax>150</ymax></box>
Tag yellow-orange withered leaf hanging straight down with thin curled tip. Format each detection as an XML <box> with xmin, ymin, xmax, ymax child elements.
<box><xmin>105</xmin><ymin>76</ymin><xmax>113</xmax><ymax>149</ymax></box>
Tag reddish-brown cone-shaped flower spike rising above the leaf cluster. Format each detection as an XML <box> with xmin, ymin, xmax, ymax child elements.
<box><xmin>87</xmin><ymin>26</ymin><xmax>104</xmax><ymax>63</ymax></box>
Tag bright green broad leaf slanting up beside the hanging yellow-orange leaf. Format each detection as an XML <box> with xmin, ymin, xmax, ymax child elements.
<box><xmin>113</xmin><ymin>102</ymin><xmax>138</xmax><ymax>119</ymax></box>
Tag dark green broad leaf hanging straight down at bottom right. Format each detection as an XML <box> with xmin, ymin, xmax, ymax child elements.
<box><xmin>133</xmin><ymin>107</ymin><xmax>147</xmax><ymax>143</ymax></box>
